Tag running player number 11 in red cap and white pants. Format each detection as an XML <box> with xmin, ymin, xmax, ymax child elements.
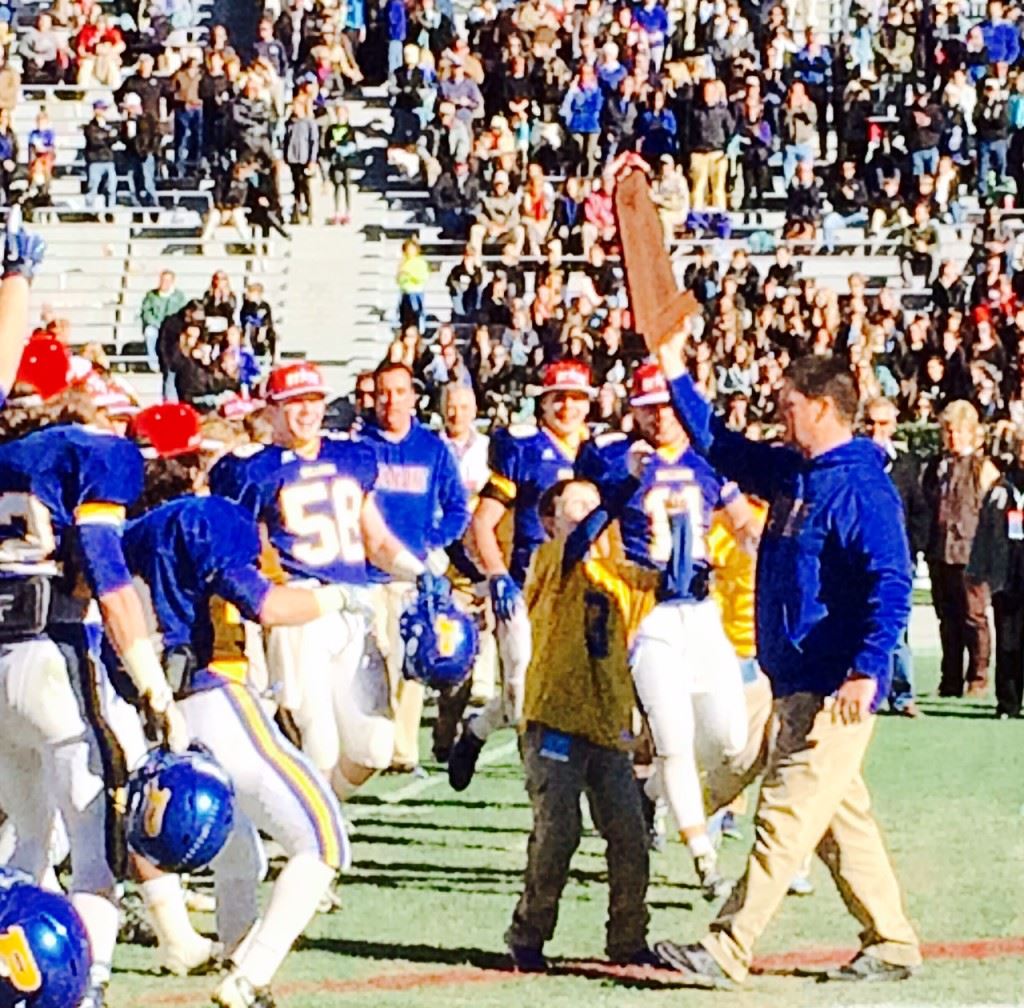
<box><xmin>578</xmin><ymin>363</ymin><xmax>749</xmax><ymax>898</ymax></box>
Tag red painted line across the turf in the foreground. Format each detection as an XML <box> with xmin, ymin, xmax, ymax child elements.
<box><xmin>136</xmin><ymin>936</ymin><xmax>1024</xmax><ymax>1008</ymax></box>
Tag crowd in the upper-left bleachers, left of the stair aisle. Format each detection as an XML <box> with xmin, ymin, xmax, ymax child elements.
<box><xmin>0</xmin><ymin>0</ymin><xmax>374</xmax><ymax>229</ymax></box>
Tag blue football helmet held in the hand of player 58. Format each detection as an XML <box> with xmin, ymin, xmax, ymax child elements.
<box><xmin>398</xmin><ymin>577</ymin><xmax>480</xmax><ymax>689</ymax></box>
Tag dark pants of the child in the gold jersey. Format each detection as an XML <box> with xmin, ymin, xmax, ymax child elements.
<box><xmin>505</xmin><ymin>724</ymin><xmax>649</xmax><ymax>961</ymax></box>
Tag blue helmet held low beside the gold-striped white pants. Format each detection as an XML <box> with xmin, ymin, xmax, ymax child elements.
<box><xmin>128</xmin><ymin>745</ymin><xmax>234</xmax><ymax>872</ymax></box>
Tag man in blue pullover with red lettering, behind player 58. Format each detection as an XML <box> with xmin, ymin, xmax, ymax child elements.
<box><xmin>362</xmin><ymin>364</ymin><xmax>469</xmax><ymax>772</ymax></box>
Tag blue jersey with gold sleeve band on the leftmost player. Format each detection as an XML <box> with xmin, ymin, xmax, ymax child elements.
<box><xmin>0</xmin><ymin>424</ymin><xmax>143</xmax><ymax>582</ymax></box>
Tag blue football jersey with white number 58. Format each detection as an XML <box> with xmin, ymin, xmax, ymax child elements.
<box><xmin>228</xmin><ymin>435</ymin><xmax>377</xmax><ymax>585</ymax></box>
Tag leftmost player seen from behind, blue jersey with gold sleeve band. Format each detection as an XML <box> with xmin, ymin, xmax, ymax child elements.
<box><xmin>0</xmin><ymin>340</ymin><xmax>188</xmax><ymax>1008</ymax></box>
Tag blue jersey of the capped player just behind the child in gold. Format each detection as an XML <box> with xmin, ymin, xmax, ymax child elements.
<box><xmin>480</xmin><ymin>426</ymin><xmax>575</xmax><ymax>585</ymax></box>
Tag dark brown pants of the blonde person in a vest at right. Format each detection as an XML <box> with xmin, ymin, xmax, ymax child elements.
<box><xmin>928</xmin><ymin>562</ymin><xmax>992</xmax><ymax>697</ymax></box>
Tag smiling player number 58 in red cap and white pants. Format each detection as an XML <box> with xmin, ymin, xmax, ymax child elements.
<box><xmin>217</xmin><ymin>362</ymin><xmax>436</xmax><ymax>801</ymax></box>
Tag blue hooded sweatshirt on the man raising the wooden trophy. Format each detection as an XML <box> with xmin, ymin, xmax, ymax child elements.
<box><xmin>671</xmin><ymin>375</ymin><xmax>912</xmax><ymax>710</ymax></box>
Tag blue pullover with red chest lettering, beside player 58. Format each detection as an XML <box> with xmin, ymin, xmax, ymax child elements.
<box><xmin>362</xmin><ymin>420</ymin><xmax>469</xmax><ymax>583</ymax></box>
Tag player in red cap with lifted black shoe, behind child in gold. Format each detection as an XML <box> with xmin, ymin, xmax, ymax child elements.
<box><xmin>449</xmin><ymin>361</ymin><xmax>594</xmax><ymax>791</ymax></box>
